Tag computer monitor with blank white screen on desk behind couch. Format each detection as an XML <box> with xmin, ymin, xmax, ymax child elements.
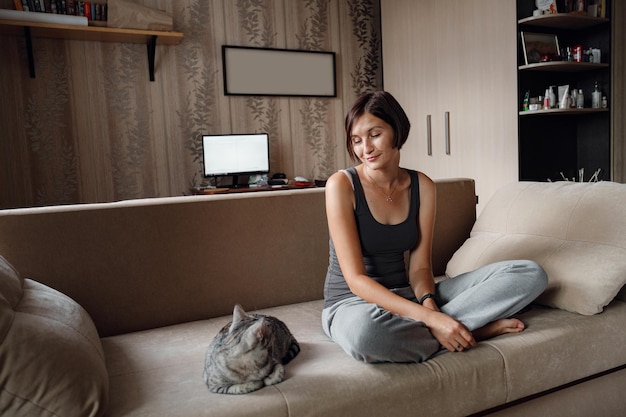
<box><xmin>202</xmin><ymin>133</ymin><xmax>270</xmax><ymax>177</ymax></box>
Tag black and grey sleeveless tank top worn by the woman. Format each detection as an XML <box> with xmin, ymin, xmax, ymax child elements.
<box><xmin>324</xmin><ymin>168</ymin><xmax>420</xmax><ymax>308</ymax></box>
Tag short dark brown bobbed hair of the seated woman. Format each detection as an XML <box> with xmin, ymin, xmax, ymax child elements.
<box><xmin>345</xmin><ymin>91</ymin><xmax>411</xmax><ymax>161</ymax></box>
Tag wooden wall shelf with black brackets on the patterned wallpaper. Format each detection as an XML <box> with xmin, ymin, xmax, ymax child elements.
<box><xmin>0</xmin><ymin>20</ymin><xmax>183</xmax><ymax>81</ymax></box>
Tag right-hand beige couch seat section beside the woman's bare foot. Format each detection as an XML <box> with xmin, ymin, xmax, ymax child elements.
<box><xmin>481</xmin><ymin>300</ymin><xmax>626</xmax><ymax>402</ymax></box>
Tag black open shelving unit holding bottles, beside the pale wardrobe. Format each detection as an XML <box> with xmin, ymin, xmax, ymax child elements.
<box><xmin>517</xmin><ymin>0</ymin><xmax>611</xmax><ymax>181</ymax></box>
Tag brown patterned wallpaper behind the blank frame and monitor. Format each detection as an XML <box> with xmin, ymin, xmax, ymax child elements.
<box><xmin>0</xmin><ymin>0</ymin><xmax>382</xmax><ymax>208</ymax></box>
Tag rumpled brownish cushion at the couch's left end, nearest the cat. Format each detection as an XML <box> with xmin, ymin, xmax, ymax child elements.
<box><xmin>0</xmin><ymin>256</ymin><xmax>109</xmax><ymax>417</ymax></box>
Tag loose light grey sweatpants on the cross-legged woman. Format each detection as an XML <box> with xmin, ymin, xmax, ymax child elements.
<box><xmin>322</xmin><ymin>260</ymin><xmax>548</xmax><ymax>362</ymax></box>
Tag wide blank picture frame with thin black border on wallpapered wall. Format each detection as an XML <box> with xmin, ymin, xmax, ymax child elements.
<box><xmin>222</xmin><ymin>45</ymin><xmax>337</xmax><ymax>97</ymax></box>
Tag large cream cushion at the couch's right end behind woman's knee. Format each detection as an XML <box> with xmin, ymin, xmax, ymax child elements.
<box><xmin>446</xmin><ymin>182</ymin><xmax>626</xmax><ymax>315</ymax></box>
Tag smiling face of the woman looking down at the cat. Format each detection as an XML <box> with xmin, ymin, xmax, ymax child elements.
<box><xmin>351</xmin><ymin>113</ymin><xmax>398</xmax><ymax>168</ymax></box>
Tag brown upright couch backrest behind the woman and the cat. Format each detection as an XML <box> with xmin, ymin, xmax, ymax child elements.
<box><xmin>0</xmin><ymin>180</ymin><xmax>475</xmax><ymax>336</ymax></box>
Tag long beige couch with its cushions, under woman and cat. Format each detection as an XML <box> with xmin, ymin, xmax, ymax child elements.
<box><xmin>0</xmin><ymin>180</ymin><xmax>626</xmax><ymax>417</ymax></box>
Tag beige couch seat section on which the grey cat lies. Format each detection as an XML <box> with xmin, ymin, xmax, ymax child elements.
<box><xmin>102</xmin><ymin>300</ymin><xmax>507</xmax><ymax>417</ymax></box>
